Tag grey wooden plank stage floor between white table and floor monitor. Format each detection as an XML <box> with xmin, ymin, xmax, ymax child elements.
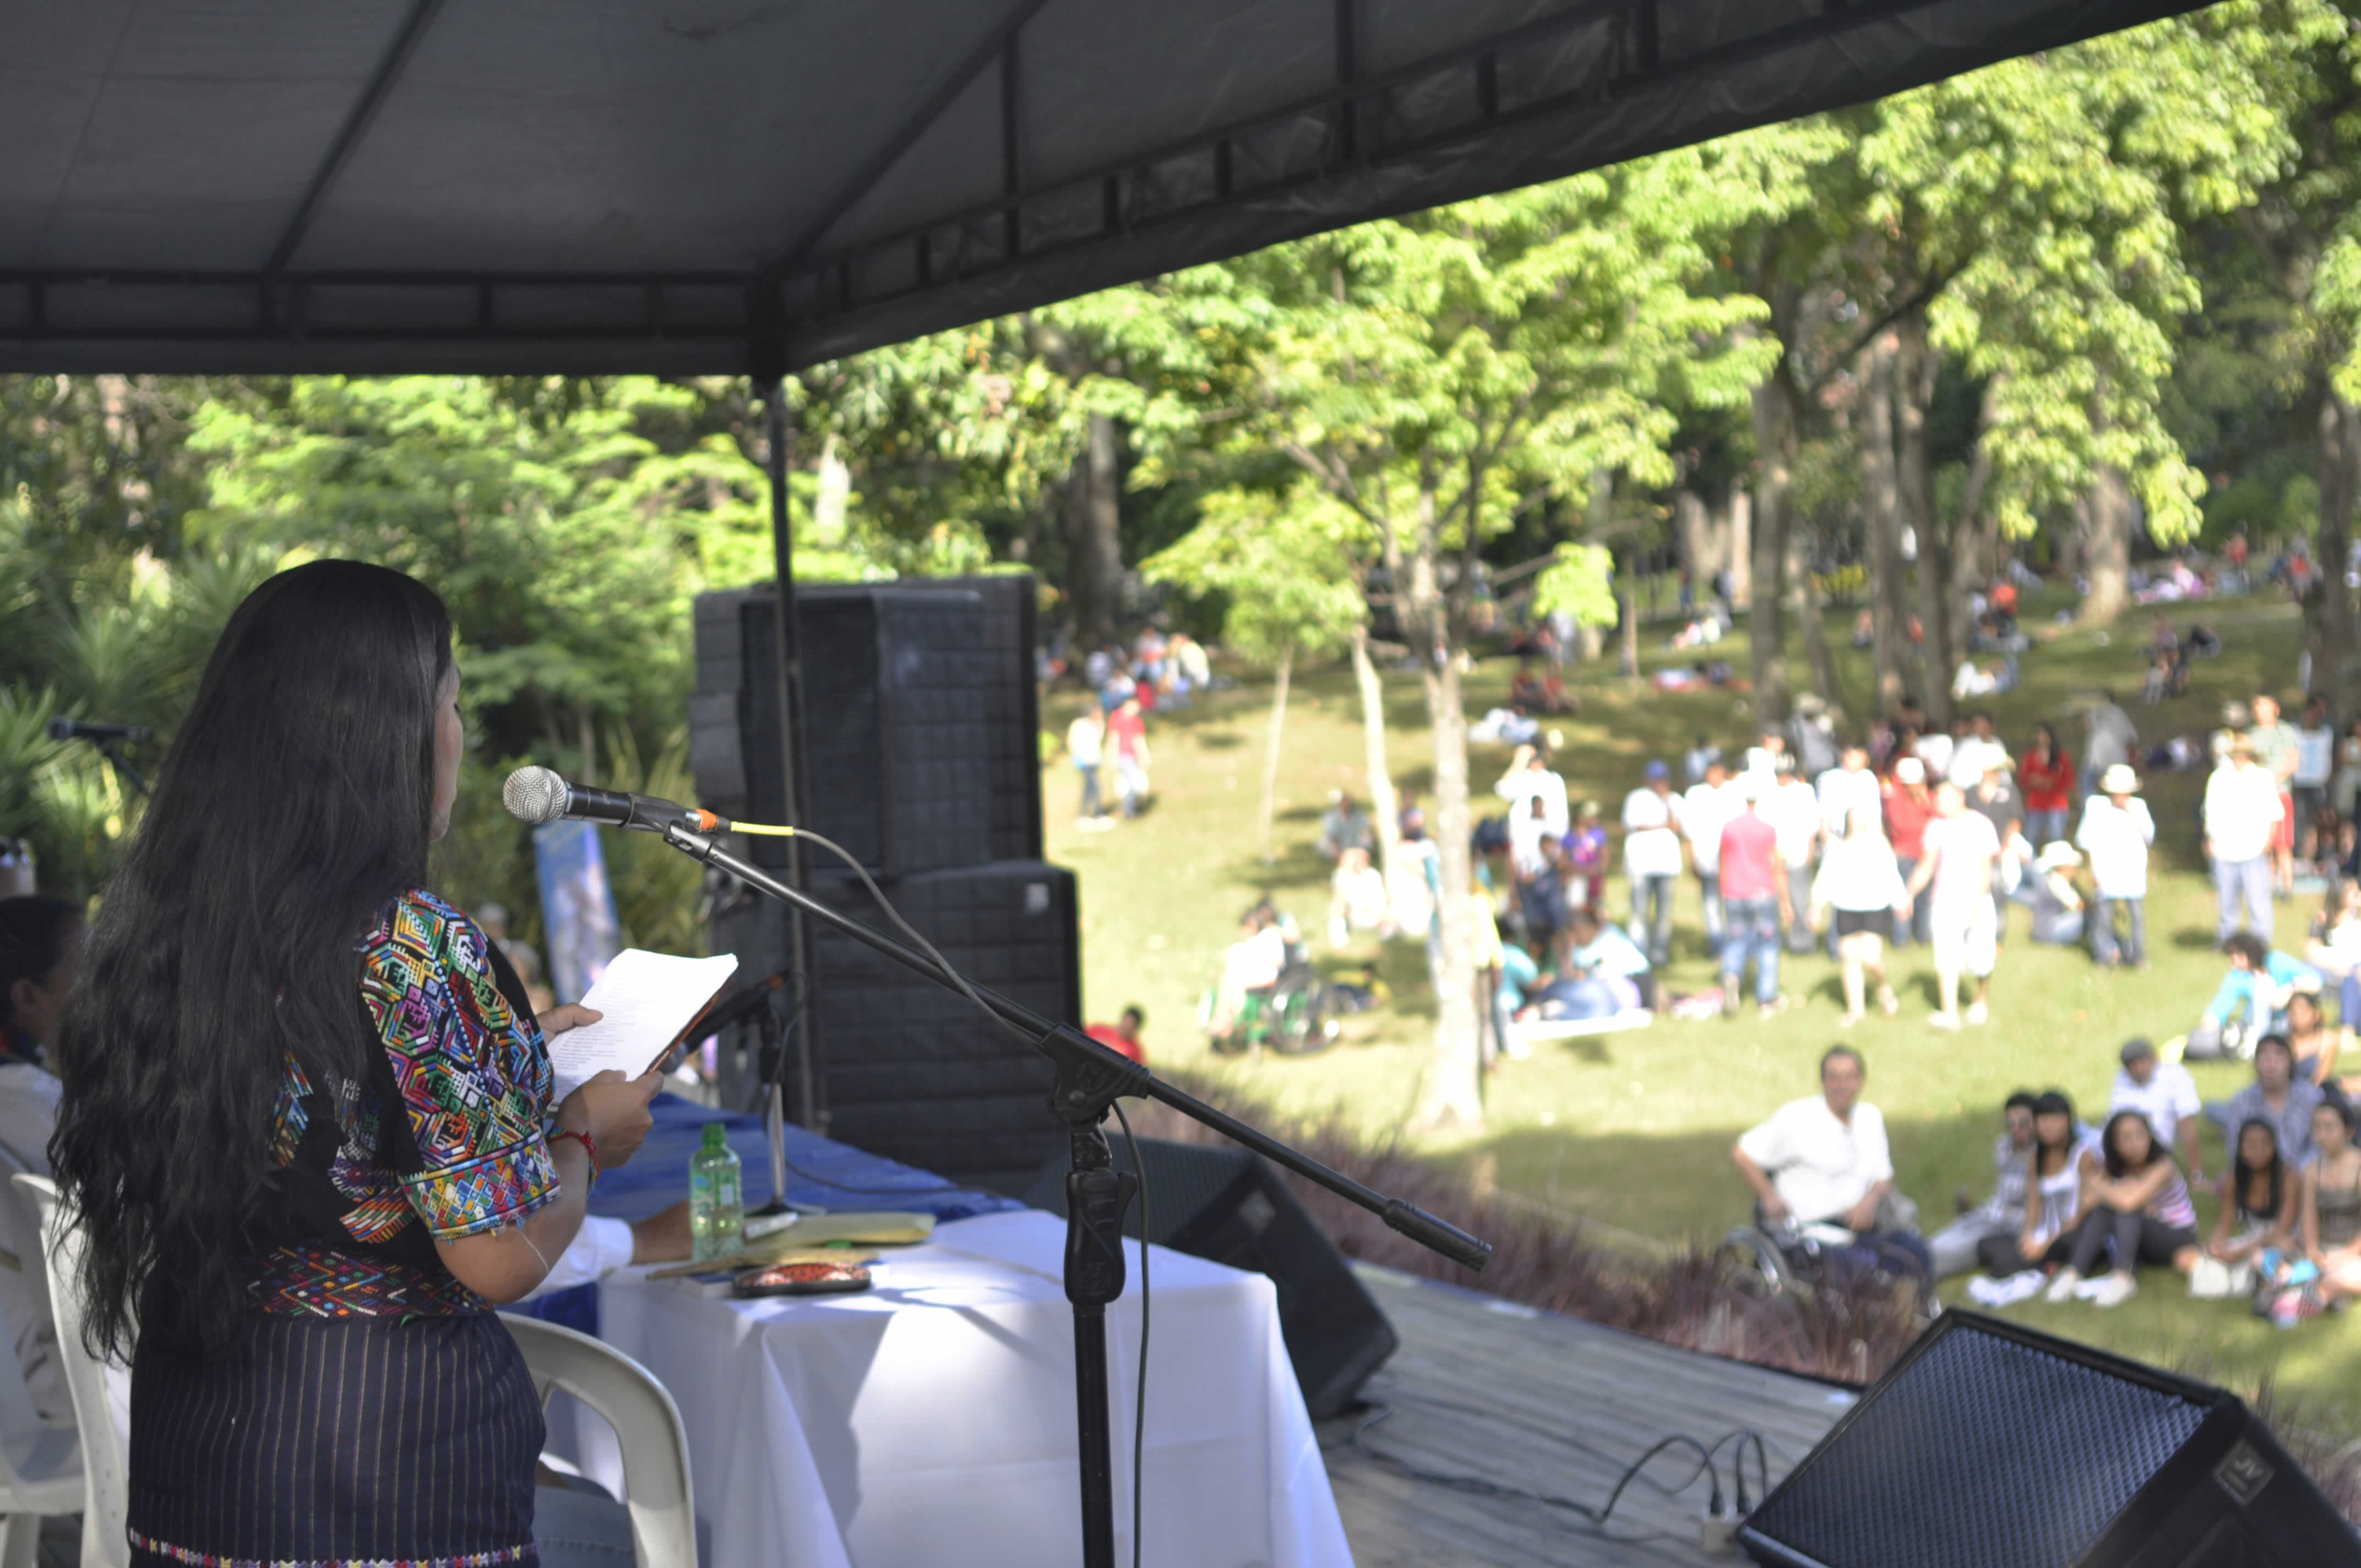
<box><xmin>1320</xmin><ymin>1264</ymin><xmax>1853</xmax><ymax>1568</ymax></box>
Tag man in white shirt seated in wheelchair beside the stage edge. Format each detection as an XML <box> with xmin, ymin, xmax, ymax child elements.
<box><xmin>1731</xmin><ymin>1046</ymin><xmax>1934</xmax><ymax>1284</ymax></box>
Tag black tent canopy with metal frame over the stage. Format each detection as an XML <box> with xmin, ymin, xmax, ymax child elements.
<box><xmin>0</xmin><ymin>0</ymin><xmax>2191</xmax><ymax>378</ymax></box>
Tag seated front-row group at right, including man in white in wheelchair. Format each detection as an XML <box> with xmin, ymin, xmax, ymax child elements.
<box><xmin>1731</xmin><ymin>1035</ymin><xmax>2361</xmax><ymax>1327</ymax></box>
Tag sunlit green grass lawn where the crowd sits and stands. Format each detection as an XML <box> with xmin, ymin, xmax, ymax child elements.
<box><xmin>1043</xmin><ymin>597</ymin><xmax>2361</xmax><ymax>1431</ymax></box>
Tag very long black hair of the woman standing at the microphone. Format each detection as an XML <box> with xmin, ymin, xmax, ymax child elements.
<box><xmin>50</xmin><ymin>560</ymin><xmax>451</xmax><ymax>1353</ymax></box>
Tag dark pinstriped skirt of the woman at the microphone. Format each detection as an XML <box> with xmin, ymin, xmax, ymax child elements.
<box><xmin>130</xmin><ymin>1313</ymin><xmax>543</xmax><ymax>1568</ymax></box>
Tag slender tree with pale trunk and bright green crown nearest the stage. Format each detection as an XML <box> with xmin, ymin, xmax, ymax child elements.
<box><xmin>1152</xmin><ymin>151</ymin><xmax>1766</xmax><ymax>1129</ymax></box>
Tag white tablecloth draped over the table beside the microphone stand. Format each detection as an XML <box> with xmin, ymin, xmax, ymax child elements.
<box><xmin>552</xmin><ymin>1209</ymin><xmax>1353</xmax><ymax>1568</ymax></box>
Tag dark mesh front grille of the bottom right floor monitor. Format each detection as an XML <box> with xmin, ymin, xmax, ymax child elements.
<box><xmin>1749</xmin><ymin>1332</ymin><xmax>2207</xmax><ymax>1568</ymax></box>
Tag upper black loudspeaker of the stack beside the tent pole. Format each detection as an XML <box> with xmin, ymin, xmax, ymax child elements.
<box><xmin>689</xmin><ymin>574</ymin><xmax>1041</xmax><ymax>874</ymax></box>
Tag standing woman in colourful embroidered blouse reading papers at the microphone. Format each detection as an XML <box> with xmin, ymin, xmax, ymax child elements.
<box><xmin>50</xmin><ymin>562</ymin><xmax>656</xmax><ymax>1566</ymax></box>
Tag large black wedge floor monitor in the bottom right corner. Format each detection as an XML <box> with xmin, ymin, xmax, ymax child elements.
<box><xmin>1738</xmin><ymin>1310</ymin><xmax>2361</xmax><ymax>1568</ymax></box>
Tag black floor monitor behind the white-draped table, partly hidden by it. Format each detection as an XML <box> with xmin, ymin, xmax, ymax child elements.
<box><xmin>1025</xmin><ymin>1138</ymin><xmax>1402</xmax><ymax>1422</ymax></box>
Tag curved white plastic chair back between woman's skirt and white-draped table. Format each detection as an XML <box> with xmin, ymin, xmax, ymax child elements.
<box><xmin>503</xmin><ymin>1313</ymin><xmax>697</xmax><ymax>1568</ymax></box>
